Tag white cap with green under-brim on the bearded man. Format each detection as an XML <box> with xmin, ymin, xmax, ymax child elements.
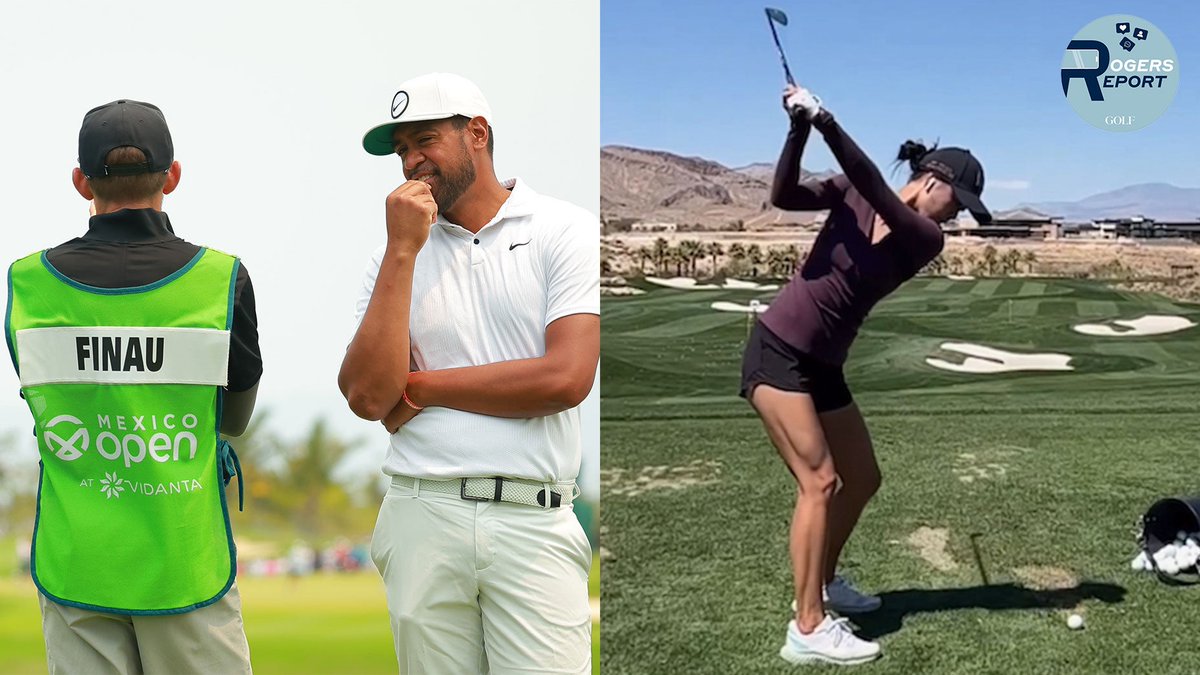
<box><xmin>362</xmin><ymin>72</ymin><xmax>492</xmax><ymax>155</ymax></box>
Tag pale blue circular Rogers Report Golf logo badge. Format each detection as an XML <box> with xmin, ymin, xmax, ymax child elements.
<box><xmin>1062</xmin><ymin>14</ymin><xmax>1180</xmax><ymax>131</ymax></box>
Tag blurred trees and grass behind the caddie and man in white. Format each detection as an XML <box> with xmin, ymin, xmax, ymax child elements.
<box><xmin>0</xmin><ymin>410</ymin><xmax>600</xmax><ymax>675</ymax></box>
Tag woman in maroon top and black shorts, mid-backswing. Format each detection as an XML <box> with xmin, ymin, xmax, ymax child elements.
<box><xmin>742</xmin><ymin>85</ymin><xmax>991</xmax><ymax>664</ymax></box>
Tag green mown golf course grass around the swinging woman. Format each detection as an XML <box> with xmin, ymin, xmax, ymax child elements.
<box><xmin>601</xmin><ymin>277</ymin><xmax>1200</xmax><ymax>675</ymax></box>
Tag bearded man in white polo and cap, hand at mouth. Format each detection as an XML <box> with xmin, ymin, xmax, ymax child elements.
<box><xmin>338</xmin><ymin>73</ymin><xmax>600</xmax><ymax>675</ymax></box>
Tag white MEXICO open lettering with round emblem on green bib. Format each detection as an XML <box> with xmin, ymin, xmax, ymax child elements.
<box><xmin>43</xmin><ymin>413</ymin><xmax>199</xmax><ymax>468</ymax></box>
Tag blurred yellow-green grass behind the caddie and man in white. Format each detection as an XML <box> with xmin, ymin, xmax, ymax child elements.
<box><xmin>0</xmin><ymin>547</ymin><xmax>600</xmax><ymax>675</ymax></box>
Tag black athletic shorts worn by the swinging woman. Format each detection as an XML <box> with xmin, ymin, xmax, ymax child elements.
<box><xmin>740</xmin><ymin>322</ymin><xmax>854</xmax><ymax>412</ymax></box>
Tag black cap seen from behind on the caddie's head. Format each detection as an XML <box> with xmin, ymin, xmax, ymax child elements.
<box><xmin>79</xmin><ymin>98</ymin><xmax>175</xmax><ymax>178</ymax></box>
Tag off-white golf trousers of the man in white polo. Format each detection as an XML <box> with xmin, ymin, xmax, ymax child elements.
<box><xmin>371</xmin><ymin>475</ymin><xmax>592</xmax><ymax>675</ymax></box>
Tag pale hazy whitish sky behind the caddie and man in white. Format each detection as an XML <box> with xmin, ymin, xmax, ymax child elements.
<box><xmin>0</xmin><ymin>0</ymin><xmax>600</xmax><ymax>494</ymax></box>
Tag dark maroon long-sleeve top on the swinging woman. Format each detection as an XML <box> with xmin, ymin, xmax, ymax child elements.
<box><xmin>761</xmin><ymin>110</ymin><xmax>943</xmax><ymax>365</ymax></box>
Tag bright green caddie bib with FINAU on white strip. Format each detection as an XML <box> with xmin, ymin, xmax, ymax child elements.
<box><xmin>5</xmin><ymin>249</ymin><xmax>239</xmax><ymax>614</ymax></box>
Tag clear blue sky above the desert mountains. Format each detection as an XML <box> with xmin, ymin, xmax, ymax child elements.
<box><xmin>600</xmin><ymin>0</ymin><xmax>1200</xmax><ymax>208</ymax></box>
